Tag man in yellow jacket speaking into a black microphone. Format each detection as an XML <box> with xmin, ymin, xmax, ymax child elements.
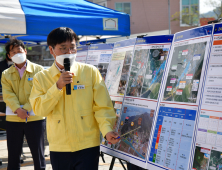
<box><xmin>30</xmin><ymin>27</ymin><xmax>119</xmax><ymax>170</ymax></box>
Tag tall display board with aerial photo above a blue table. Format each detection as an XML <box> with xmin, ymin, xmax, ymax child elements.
<box><xmin>147</xmin><ymin>25</ymin><xmax>213</xmax><ymax>170</ymax></box>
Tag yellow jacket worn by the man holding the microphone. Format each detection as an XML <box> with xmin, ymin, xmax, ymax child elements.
<box><xmin>30</xmin><ymin>62</ymin><xmax>116</xmax><ymax>152</ymax></box>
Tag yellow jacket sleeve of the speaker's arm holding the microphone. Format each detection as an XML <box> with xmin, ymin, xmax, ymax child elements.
<box><xmin>29</xmin><ymin>76</ymin><xmax>63</xmax><ymax>117</ymax></box>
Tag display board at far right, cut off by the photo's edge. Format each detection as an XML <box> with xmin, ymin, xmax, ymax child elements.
<box><xmin>193</xmin><ymin>24</ymin><xmax>222</xmax><ymax>170</ymax></box>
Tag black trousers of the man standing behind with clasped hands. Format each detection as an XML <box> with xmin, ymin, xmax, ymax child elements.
<box><xmin>6</xmin><ymin>120</ymin><xmax>46</xmax><ymax>170</ymax></box>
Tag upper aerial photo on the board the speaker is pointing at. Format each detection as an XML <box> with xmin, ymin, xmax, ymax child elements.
<box><xmin>127</xmin><ymin>48</ymin><xmax>169</xmax><ymax>99</ymax></box>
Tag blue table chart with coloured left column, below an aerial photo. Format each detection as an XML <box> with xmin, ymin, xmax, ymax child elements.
<box><xmin>149</xmin><ymin>106</ymin><xmax>196</xmax><ymax>170</ymax></box>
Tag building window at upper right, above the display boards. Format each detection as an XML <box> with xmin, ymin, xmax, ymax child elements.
<box><xmin>180</xmin><ymin>0</ymin><xmax>199</xmax><ymax>26</ymax></box>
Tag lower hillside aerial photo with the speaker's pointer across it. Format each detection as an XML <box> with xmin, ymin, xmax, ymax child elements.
<box><xmin>114</xmin><ymin>105</ymin><xmax>154</xmax><ymax>159</ymax></box>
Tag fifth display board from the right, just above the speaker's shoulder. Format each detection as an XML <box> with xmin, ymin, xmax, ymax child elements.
<box><xmin>86</xmin><ymin>44</ymin><xmax>114</xmax><ymax>81</ymax></box>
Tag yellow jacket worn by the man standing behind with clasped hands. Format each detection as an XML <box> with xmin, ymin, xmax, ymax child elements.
<box><xmin>1</xmin><ymin>60</ymin><xmax>44</xmax><ymax>122</ymax></box>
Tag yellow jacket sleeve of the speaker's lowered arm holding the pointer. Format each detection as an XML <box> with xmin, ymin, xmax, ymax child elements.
<box><xmin>93</xmin><ymin>68</ymin><xmax>116</xmax><ymax>137</ymax></box>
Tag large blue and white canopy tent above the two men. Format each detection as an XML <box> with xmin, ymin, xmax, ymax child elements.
<box><xmin>0</xmin><ymin>0</ymin><xmax>130</xmax><ymax>35</ymax></box>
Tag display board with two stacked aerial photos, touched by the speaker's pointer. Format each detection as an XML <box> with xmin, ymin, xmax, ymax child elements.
<box><xmin>101</xmin><ymin>35</ymin><xmax>173</xmax><ymax>168</ymax></box>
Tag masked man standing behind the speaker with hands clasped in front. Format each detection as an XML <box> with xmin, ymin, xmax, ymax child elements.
<box><xmin>1</xmin><ymin>39</ymin><xmax>45</xmax><ymax>170</ymax></box>
